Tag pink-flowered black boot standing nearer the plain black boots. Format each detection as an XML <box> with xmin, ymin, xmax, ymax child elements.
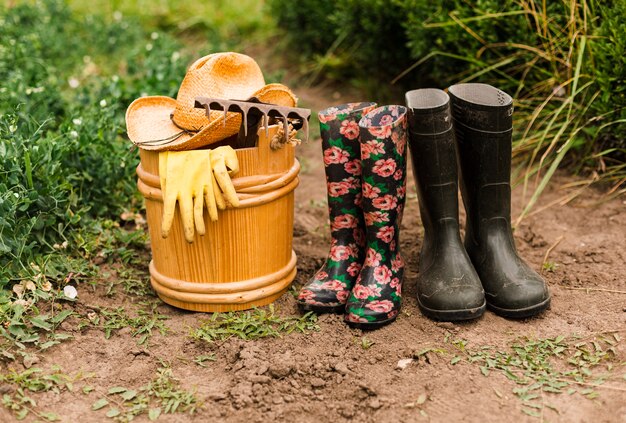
<box><xmin>345</xmin><ymin>106</ymin><xmax>407</xmax><ymax>329</ymax></box>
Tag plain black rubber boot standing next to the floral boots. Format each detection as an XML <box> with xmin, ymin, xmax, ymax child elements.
<box><xmin>406</xmin><ymin>88</ymin><xmax>485</xmax><ymax>321</ymax></box>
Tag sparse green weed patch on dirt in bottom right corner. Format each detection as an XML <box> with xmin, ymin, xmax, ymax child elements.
<box><xmin>450</xmin><ymin>332</ymin><xmax>626</xmax><ymax>417</ymax></box>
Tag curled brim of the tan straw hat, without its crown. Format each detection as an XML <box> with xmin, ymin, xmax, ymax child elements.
<box><xmin>126</xmin><ymin>84</ymin><xmax>297</xmax><ymax>151</ymax></box>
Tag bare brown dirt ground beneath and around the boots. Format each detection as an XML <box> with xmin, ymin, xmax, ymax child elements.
<box><xmin>0</xmin><ymin>90</ymin><xmax>626</xmax><ymax>423</ymax></box>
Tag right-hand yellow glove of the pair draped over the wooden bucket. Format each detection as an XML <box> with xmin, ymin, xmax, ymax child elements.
<box><xmin>211</xmin><ymin>146</ymin><xmax>239</xmax><ymax>210</ymax></box>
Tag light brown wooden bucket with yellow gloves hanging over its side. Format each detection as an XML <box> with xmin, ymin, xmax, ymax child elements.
<box><xmin>137</xmin><ymin>126</ymin><xmax>300</xmax><ymax>312</ymax></box>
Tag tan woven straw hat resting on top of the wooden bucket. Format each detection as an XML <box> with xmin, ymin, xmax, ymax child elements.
<box><xmin>126</xmin><ymin>52</ymin><xmax>297</xmax><ymax>151</ymax></box>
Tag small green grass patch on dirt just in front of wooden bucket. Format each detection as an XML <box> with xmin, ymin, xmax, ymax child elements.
<box><xmin>189</xmin><ymin>305</ymin><xmax>319</xmax><ymax>344</ymax></box>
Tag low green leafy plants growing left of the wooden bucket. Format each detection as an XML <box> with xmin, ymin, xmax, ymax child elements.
<box><xmin>0</xmin><ymin>0</ymin><xmax>193</xmax><ymax>359</ymax></box>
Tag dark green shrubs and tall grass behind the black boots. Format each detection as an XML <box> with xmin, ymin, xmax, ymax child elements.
<box><xmin>269</xmin><ymin>0</ymin><xmax>626</xmax><ymax>214</ymax></box>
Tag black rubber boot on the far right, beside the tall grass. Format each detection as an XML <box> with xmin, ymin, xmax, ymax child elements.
<box><xmin>449</xmin><ymin>84</ymin><xmax>550</xmax><ymax>318</ymax></box>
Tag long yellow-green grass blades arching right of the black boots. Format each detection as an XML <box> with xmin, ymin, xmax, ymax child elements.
<box><xmin>404</xmin><ymin>0</ymin><xmax>626</xmax><ymax>219</ymax></box>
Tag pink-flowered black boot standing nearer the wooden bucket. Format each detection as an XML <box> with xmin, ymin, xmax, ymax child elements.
<box><xmin>298</xmin><ymin>103</ymin><xmax>376</xmax><ymax>313</ymax></box>
